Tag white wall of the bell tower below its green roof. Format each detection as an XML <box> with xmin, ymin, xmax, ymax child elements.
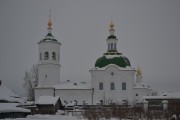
<box><xmin>38</xmin><ymin>41</ymin><xmax>60</xmax><ymax>87</ymax></box>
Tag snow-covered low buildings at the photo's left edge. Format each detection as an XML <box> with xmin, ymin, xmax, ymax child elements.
<box><xmin>0</xmin><ymin>80</ymin><xmax>31</xmax><ymax>119</ymax></box>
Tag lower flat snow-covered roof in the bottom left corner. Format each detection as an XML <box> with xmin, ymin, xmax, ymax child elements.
<box><xmin>0</xmin><ymin>103</ymin><xmax>31</xmax><ymax>113</ymax></box>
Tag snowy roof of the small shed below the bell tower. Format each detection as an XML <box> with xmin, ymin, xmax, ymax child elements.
<box><xmin>36</xmin><ymin>96</ymin><xmax>60</xmax><ymax>105</ymax></box>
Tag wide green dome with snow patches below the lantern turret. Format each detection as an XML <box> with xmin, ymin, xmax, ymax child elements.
<box><xmin>95</xmin><ymin>56</ymin><xmax>131</xmax><ymax>68</ymax></box>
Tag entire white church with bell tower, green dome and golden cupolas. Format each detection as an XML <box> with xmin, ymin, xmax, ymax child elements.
<box><xmin>35</xmin><ymin>18</ymin><xmax>151</xmax><ymax>105</ymax></box>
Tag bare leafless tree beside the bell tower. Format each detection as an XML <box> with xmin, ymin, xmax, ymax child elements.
<box><xmin>23</xmin><ymin>65</ymin><xmax>38</xmax><ymax>101</ymax></box>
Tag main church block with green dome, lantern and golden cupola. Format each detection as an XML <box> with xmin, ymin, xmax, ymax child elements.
<box><xmin>90</xmin><ymin>20</ymin><xmax>135</xmax><ymax>105</ymax></box>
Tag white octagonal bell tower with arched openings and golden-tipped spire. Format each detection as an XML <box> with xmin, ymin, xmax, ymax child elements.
<box><xmin>38</xmin><ymin>15</ymin><xmax>61</xmax><ymax>87</ymax></box>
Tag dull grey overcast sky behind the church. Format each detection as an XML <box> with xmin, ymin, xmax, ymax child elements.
<box><xmin>0</xmin><ymin>0</ymin><xmax>180</xmax><ymax>95</ymax></box>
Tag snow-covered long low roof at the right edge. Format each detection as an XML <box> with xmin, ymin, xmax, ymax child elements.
<box><xmin>143</xmin><ymin>92</ymin><xmax>180</xmax><ymax>99</ymax></box>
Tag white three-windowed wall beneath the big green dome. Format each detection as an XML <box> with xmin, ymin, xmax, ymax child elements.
<box><xmin>90</xmin><ymin>65</ymin><xmax>135</xmax><ymax>104</ymax></box>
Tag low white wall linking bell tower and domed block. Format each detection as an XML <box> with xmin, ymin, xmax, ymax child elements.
<box><xmin>55</xmin><ymin>89</ymin><xmax>92</xmax><ymax>105</ymax></box>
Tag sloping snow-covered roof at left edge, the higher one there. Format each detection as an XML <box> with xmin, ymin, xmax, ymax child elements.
<box><xmin>0</xmin><ymin>84</ymin><xmax>22</xmax><ymax>102</ymax></box>
